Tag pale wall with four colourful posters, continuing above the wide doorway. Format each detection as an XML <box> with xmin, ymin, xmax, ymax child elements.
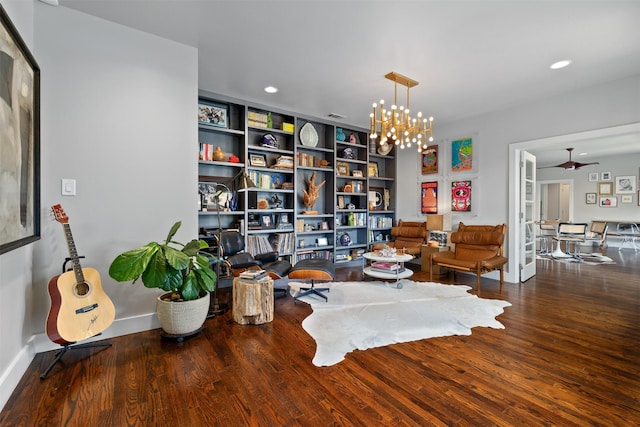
<box><xmin>398</xmin><ymin>76</ymin><xmax>640</xmax><ymax>283</ymax></box>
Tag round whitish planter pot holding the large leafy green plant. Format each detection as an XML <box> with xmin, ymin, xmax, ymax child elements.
<box><xmin>156</xmin><ymin>292</ymin><xmax>210</xmax><ymax>335</ymax></box>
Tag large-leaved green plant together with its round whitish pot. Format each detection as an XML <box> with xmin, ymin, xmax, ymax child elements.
<box><xmin>109</xmin><ymin>221</ymin><xmax>216</xmax><ymax>336</ymax></box>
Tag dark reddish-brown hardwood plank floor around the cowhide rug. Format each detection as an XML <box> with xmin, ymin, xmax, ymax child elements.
<box><xmin>0</xmin><ymin>249</ymin><xmax>640</xmax><ymax>426</ymax></box>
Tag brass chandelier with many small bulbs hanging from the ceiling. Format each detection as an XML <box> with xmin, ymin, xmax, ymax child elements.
<box><xmin>369</xmin><ymin>71</ymin><xmax>433</xmax><ymax>153</ymax></box>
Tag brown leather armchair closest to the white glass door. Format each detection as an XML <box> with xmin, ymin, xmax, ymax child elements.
<box><xmin>429</xmin><ymin>222</ymin><xmax>508</xmax><ymax>292</ymax></box>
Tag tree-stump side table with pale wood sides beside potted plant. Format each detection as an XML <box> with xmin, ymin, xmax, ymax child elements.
<box><xmin>232</xmin><ymin>277</ymin><xmax>273</xmax><ymax>325</ymax></box>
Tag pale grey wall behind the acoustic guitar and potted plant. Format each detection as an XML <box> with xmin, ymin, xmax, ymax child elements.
<box><xmin>0</xmin><ymin>2</ymin><xmax>198</xmax><ymax>412</ymax></box>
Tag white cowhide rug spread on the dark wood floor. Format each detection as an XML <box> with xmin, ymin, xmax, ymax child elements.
<box><xmin>289</xmin><ymin>280</ymin><xmax>511</xmax><ymax>366</ymax></box>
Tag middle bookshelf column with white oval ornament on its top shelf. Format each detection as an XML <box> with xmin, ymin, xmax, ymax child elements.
<box><xmin>295</xmin><ymin>118</ymin><xmax>335</xmax><ymax>262</ymax></box>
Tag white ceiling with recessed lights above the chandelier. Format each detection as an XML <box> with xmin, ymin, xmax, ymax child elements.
<box><xmin>53</xmin><ymin>0</ymin><xmax>640</xmax><ymax>165</ymax></box>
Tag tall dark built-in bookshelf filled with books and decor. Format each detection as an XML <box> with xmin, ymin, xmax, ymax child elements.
<box><xmin>198</xmin><ymin>91</ymin><xmax>396</xmax><ymax>270</ymax></box>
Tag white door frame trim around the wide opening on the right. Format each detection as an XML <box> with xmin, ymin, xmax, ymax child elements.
<box><xmin>505</xmin><ymin>123</ymin><xmax>640</xmax><ymax>283</ymax></box>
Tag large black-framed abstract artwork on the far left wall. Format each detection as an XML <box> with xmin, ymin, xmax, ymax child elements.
<box><xmin>0</xmin><ymin>5</ymin><xmax>40</xmax><ymax>254</ymax></box>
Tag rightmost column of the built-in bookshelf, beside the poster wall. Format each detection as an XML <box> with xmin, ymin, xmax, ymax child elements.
<box><xmin>367</xmin><ymin>151</ymin><xmax>397</xmax><ymax>249</ymax></box>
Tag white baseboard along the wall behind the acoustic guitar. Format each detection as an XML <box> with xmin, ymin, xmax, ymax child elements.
<box><xmin>0</xmin><ymin>313</ymin><xmax>160</xmax><ymax>411</ymax></box>
